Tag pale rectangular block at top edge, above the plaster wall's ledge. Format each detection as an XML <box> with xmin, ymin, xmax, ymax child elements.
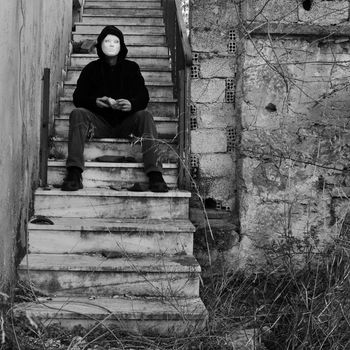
<box><xmin>247</xmin><ymin>0</ymin><xmax>298</xmax><ymax>23</ymax></box>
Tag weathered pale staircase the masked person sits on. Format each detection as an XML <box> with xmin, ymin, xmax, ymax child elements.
<box><xmin>16</xmin><ymin>0</ymin><xmax>207</xmax><ymax>334</ymax></box>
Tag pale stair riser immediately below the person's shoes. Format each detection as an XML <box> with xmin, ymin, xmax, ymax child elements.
<box><xmin>35</xmin><ymin>191</ymin><xmax>188</xmax><ymax>219</ymax></box>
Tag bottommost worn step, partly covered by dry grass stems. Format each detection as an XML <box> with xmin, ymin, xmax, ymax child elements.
<box><xmin>14</xmin><ymin>297</ymin><xmax>208</xmax><ymax>336</ymax></box>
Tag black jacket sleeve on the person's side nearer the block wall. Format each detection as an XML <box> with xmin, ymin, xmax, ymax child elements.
<box><xmin>128</xmin><ymin>62</ymin><xmax>149</xmax><ymax>112</ymax></box>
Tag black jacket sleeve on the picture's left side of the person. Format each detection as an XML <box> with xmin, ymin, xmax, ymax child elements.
<box><xmin>73</xmin><ymin>65</ymin><xmax>99</xmax><ymax>110</ymax></box>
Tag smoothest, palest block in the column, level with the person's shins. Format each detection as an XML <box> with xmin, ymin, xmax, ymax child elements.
<box><xmin>191</xmin><ymin>129</ymin><xmax>227</xmax><ymax>153</ymax></box>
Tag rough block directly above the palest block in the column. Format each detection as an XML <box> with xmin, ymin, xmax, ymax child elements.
<box><xmin>196</xmin><ymin>103</ymin><xmax>235</xmax><ymax>128</ymax></box>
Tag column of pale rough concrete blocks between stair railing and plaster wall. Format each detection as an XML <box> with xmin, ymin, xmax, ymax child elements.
<box><xmin>190</xmin><ymin>0</ymin><xmax>238</xmax><ymax>211</ymax></box>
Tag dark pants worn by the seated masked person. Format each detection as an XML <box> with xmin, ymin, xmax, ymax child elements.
<box><xmin>66</xmin><ymin>108</ymin><xmax>162</xmax><ymax>174</ymax></box>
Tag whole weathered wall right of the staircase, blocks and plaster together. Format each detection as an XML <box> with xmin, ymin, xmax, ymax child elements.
<box><xmin>190</xmin><ymin>0</ymin><xmax>350</xmax><ymax>267</ymax></box>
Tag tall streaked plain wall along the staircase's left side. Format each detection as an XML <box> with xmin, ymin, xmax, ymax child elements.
<box><xmin>0</xmin><ymin>0</ymin><xmax>72</xmax><ymax>293</ymax></box>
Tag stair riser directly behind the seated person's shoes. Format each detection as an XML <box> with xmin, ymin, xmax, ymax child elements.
<box><xmin>48</xmin><ymin>166</ymin><xmax>177</xmax><ymax>188</ymax></box>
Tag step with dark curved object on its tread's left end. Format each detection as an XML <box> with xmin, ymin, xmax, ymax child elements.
<box><xmin>28</xmin><ymin>217</ymin><xmax>195</xmax><ymax>255</ymax></box>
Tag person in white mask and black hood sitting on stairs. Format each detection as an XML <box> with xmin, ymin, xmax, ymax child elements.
<box><xmin>61</xmin><ymin>26</ymin><xmax>168</xmax><ymax>192</ymax></box>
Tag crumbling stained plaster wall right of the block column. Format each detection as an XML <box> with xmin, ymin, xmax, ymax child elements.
<box><xmin>240</xmin><ymin>0</ymin><xmax>350</xmax><ymax>266</ymax></box>
